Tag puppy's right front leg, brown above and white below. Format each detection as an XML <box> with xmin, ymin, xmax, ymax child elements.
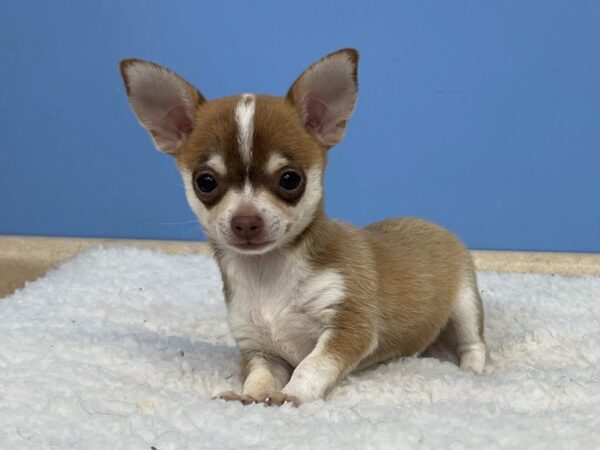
<box><xmin>266</xmin><ymin>329</ymin><xmax>376</xmax><ymax>405</ymax></box>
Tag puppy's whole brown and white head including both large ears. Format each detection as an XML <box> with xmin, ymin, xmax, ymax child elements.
<box><xmin>121</xmin><ymin>49</ymin><xmax>358</xmax><ymax>254</ymax></box>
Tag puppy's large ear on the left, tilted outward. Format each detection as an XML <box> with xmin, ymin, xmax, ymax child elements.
<box><xmin>120</xmin><ymin>59</ymin><xmax>205</xmax><ymax>153</ymax></box>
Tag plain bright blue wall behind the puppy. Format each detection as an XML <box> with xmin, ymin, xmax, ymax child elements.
<box><xmin>0</xmin><ymin>0</ymin><xmax>600</xmax><ymax>252</ymax></box>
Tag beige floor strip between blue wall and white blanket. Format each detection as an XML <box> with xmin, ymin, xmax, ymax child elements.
<box><xmin>0</xmin><ymin>236</ymin><xmax>600</xmax><ymax>298</ymax></box>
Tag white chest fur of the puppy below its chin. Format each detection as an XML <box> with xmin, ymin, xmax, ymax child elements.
<box><xmin>222</xmin><ymin>254</ymin><xmax>344</xmax><ymax>367</ymax></box>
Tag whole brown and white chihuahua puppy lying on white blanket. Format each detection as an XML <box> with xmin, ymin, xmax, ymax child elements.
<box><xmin>120</xmin><ymin>49</ymin><xmax>486</xmax><ymax>405</ymax></box>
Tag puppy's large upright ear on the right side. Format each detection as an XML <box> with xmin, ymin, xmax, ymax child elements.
<box><xmin>287</xmin><ymin>48</ymin><xmax>358</xmax><ymax>147</ymax></box>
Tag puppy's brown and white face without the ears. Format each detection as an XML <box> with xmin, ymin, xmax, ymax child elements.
<box><xmin>176</xmin><ymin>95</ymin><xmax>326</xmax><ymax>254</ymax></box>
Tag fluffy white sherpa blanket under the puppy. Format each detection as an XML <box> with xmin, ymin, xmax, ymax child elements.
<box><xmin>0</xmin><ymin>249</ymin><xmax>600</xmax><ymax>450</ymax></box>
